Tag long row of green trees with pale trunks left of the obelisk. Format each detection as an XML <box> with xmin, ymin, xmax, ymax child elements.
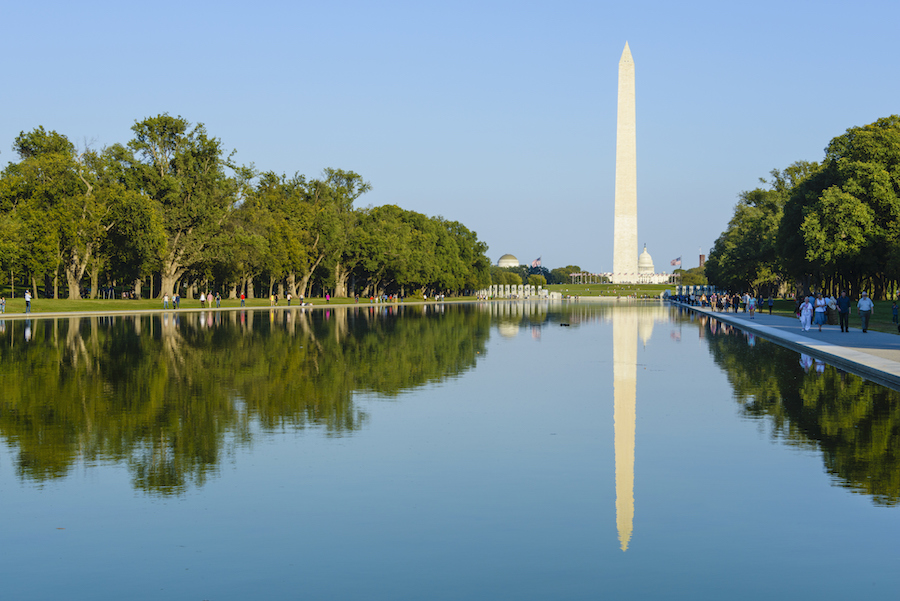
<box><xmin>0</xmin><ymin>114</ymin><xmax>490</xmax><ymax>299</ymax></box>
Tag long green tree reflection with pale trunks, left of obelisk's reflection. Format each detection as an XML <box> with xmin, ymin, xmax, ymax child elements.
<box><xmin>0</xmin><ymin>306</ymin><xmax>490</xmax><ymax>495</ymax></box>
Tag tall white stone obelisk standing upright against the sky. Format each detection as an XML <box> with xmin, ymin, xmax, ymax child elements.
<box><xmin>612</xmin><ymin>42</ymin><xmax>638</xmax><ymax>283</ymax></box>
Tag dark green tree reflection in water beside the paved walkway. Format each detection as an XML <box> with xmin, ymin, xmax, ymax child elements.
<box><xmin>700</xmin><ymin>318</ymin><xmax>900</xmax><ymax>505</ymax></box>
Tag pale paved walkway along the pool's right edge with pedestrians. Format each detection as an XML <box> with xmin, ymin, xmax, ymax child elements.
<box><xmin>672</xmin><ymin>302</ymin><xmax>900</xmax><ymax>390</ymax></box>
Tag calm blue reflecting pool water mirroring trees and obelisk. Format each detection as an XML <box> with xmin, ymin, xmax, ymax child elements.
<box><xmin>0</xmin><ymin>303</ymin><xmax>900</xmax><ymax>600</ymax></box>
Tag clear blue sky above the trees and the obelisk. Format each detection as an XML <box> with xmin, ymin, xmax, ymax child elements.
<box><xmin>0</xmin><ymin>0</ymin><xmax>900</xmax><ymax>271</ymax></box>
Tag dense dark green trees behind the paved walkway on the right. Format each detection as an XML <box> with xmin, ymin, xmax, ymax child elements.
<box><xmin>705</xmin><ymin>115</ymin><xmax>900</xmax><ymax>298</ymax></box>
